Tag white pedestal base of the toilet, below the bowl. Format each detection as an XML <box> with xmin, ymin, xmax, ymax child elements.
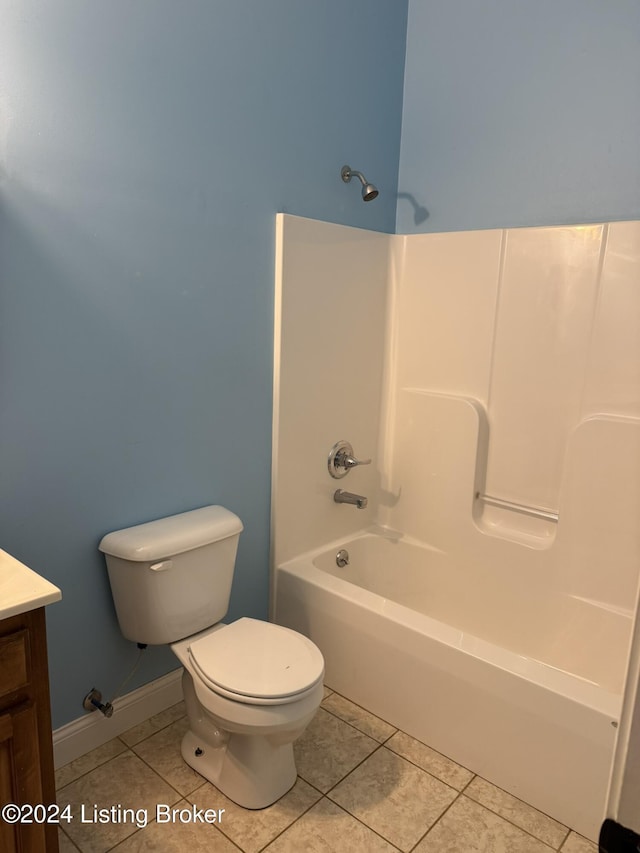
<box><xmin>181</xmin><ymin>730</ymin><xmax>297</xmax><ymax>809</ymax></box>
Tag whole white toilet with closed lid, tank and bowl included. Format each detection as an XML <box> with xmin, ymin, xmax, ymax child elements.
<box><xmin>99</xmin><ymin>506</ymin><xmax>324</xmax><ymax>809</ymax></box>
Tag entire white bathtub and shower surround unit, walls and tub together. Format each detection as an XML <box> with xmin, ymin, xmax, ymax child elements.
<box><xmin>272</xmin><ymin>216</ymin><xmax>640</xmax><ymax>839</ymax></box>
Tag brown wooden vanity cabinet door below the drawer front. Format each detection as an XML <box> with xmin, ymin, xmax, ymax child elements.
<box><xmin>0</xmin><ymin>702</ymin><xmax>47</xmax><ymax>853</ymax></box>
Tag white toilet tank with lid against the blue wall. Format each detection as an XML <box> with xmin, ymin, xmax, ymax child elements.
<box><xmin>98</xmin><ymin>506</ymin><xmax>242</xmax><ymax>645</ymax></box>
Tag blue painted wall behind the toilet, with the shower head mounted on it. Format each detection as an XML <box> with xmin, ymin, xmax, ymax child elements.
<box><xmin>0</xmin><ymin>0</ymin><xmax>407</xmax><ymax>726</ymax></box>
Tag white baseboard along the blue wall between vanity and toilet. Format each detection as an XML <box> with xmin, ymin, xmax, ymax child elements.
<box><xmin>53</xmin><ymin>667</ymin><xmax>182</xmax><ymax>769</ymax></box>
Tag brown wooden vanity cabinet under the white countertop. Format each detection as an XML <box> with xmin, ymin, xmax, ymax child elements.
<box><xmin>0</xmin><ymin>607</ymin><xmax>58</xmax><ymax>853</ymax></box>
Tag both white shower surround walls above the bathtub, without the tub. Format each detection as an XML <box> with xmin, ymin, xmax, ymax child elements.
<box><xmin>273</xmin><ymin>215</ymin><xmax>640</xmax><ymax>612</ymax></box>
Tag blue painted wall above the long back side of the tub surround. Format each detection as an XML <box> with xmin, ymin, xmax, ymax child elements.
<box><xmin>397</xmin><ymin>0</ymin><xmax>640</xmax><ymax>233</ymax></box>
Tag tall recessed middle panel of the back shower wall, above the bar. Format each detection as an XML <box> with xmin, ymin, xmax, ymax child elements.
<box><xmin>486</xmin><ymin>225</ymin><xmax>603</xmax><ymax>508</ymax></box>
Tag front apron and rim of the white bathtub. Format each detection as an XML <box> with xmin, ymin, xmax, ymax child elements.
<box><xmin>276</xmin><ymin>536</ymin><xmax>620</xmax><ymax>839</ymax></box>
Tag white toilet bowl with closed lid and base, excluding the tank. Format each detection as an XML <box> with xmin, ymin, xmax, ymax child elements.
<box><xmin>171</xmin><ymin>618</ymin><xmax>324</xmax><ymax>809</ymax></box>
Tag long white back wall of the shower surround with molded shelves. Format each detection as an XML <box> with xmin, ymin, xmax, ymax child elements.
<box><xmin>379</xmin><ymin>222</ymin><xmax>640</xmax><ymax>613</ymax></box>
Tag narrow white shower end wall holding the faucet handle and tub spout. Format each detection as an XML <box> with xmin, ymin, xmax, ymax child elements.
<box><xmin>272</xmin><ymin>214</ymin><xmax>389</xmax><ymax>562</ymax></box>
